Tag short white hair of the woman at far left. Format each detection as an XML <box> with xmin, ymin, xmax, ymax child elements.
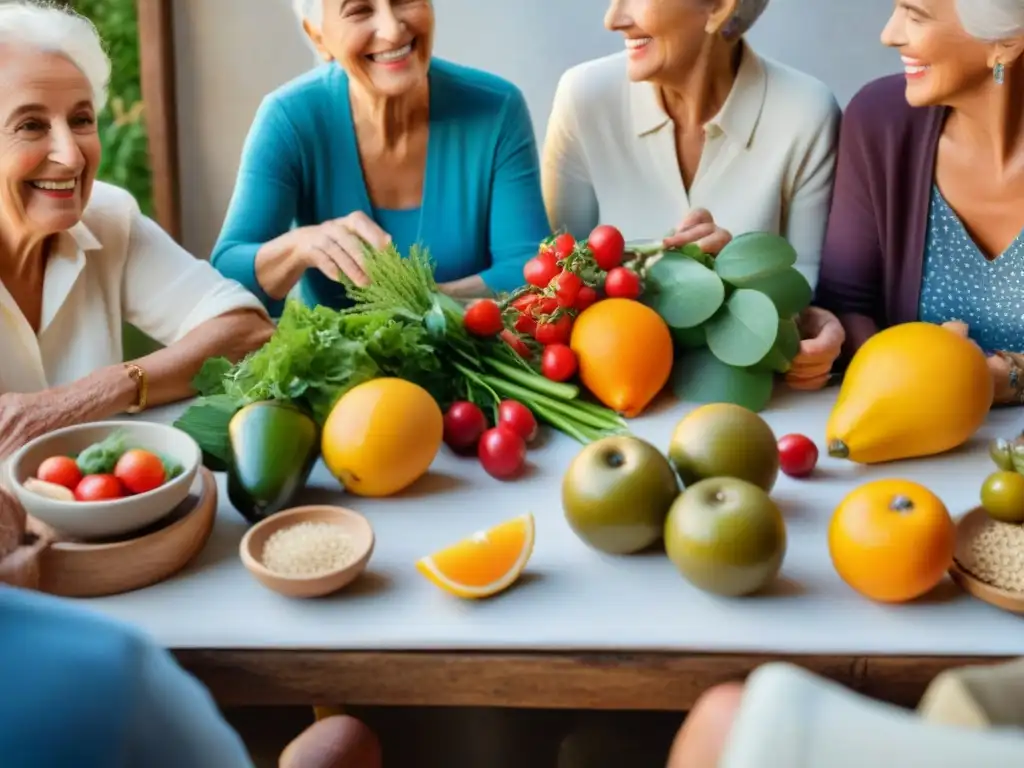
<box><xmin>0</xmin><ymin>0</ymin><xmax>111</xmax><ymax>112</ymax></box>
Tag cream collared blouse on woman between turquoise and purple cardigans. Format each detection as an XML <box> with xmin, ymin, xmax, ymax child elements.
<box><xmin>543</xmin><ymin>43</ymin><xmax>842</xmax><ymax>287</ymax></box>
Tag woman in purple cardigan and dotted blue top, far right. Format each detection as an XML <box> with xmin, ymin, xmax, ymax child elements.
<box><xmin>795</xmin><ymin>0</ymin><xmax>1024</xmax><ymax>403</ymax></box>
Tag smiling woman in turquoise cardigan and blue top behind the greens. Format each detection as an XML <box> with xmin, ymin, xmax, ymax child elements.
<box><xmin>211</xmin><ymin>0</ymin><xmax>550</xmax><ymax>313</ymax></box>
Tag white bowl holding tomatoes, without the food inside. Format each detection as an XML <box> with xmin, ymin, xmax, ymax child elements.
<box><xmin>6</xmin><ymin>421</ymin><xmax>203</xmax><ymax>541</ymax></box>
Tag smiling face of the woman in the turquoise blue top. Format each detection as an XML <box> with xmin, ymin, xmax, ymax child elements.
<box><xmin>305</xmin><ymin>0</ymin><xmax>434</xmax><ymax>96</ymax></box>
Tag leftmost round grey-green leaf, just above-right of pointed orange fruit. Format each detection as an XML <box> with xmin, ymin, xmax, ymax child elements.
<box><xmin>647</xmin><ymin>253</ymin><xmax>725</xmax><ymax>328</ymax></box>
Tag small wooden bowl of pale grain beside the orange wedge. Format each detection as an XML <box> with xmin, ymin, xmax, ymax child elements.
<box><xmin>240</xmin><ymin>505</ymin><xmax>374</xmax><ymax>597</ymax></box>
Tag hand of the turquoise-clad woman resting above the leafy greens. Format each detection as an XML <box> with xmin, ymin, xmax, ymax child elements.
<box><xmin>295</xmin><ymin>211</ymin><xmax>391</xmax><ymax>287</ymax></box>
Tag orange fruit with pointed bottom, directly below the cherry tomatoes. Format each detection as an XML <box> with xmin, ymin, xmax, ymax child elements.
<box><xmin>569</xmin><ymin>299</ymin><xmax>673</xmax><ymax>418</ymax></box>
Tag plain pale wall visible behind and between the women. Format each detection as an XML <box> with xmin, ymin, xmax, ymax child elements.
<box><xmin>174</xmin><ymin>0</ymin><xmax>898</xmax><ymax>257</ymax></box>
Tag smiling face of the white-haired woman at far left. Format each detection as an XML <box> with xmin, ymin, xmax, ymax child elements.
<box><xmin>0</xmin><ymin>45</ymin><xmax>100</xmax><ymax>237</ymax></box>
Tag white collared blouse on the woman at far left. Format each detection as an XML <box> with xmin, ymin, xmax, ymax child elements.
<box><xmin>0</xmin><ymin>181</ymin><xmax>265</xmax><ymax>392</ymax></box>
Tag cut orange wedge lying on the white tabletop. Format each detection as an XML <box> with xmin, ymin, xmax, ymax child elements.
<box><xmin>416</xmin><ymin>512</ymin><xmax>534</xmax><ymax>598</ymax></box>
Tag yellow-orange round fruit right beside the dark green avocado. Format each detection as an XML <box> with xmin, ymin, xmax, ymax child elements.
<box><xmin>321</xmin><ymin>378</ymin><xmax>444</xmax><ymax>497</ymax></box>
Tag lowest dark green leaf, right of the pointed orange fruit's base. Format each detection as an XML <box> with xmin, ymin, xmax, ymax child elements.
<box><xmin>672</xmin><ymin>349</ymin><xmax>775</xmax><ymax>412</ymax></box>
